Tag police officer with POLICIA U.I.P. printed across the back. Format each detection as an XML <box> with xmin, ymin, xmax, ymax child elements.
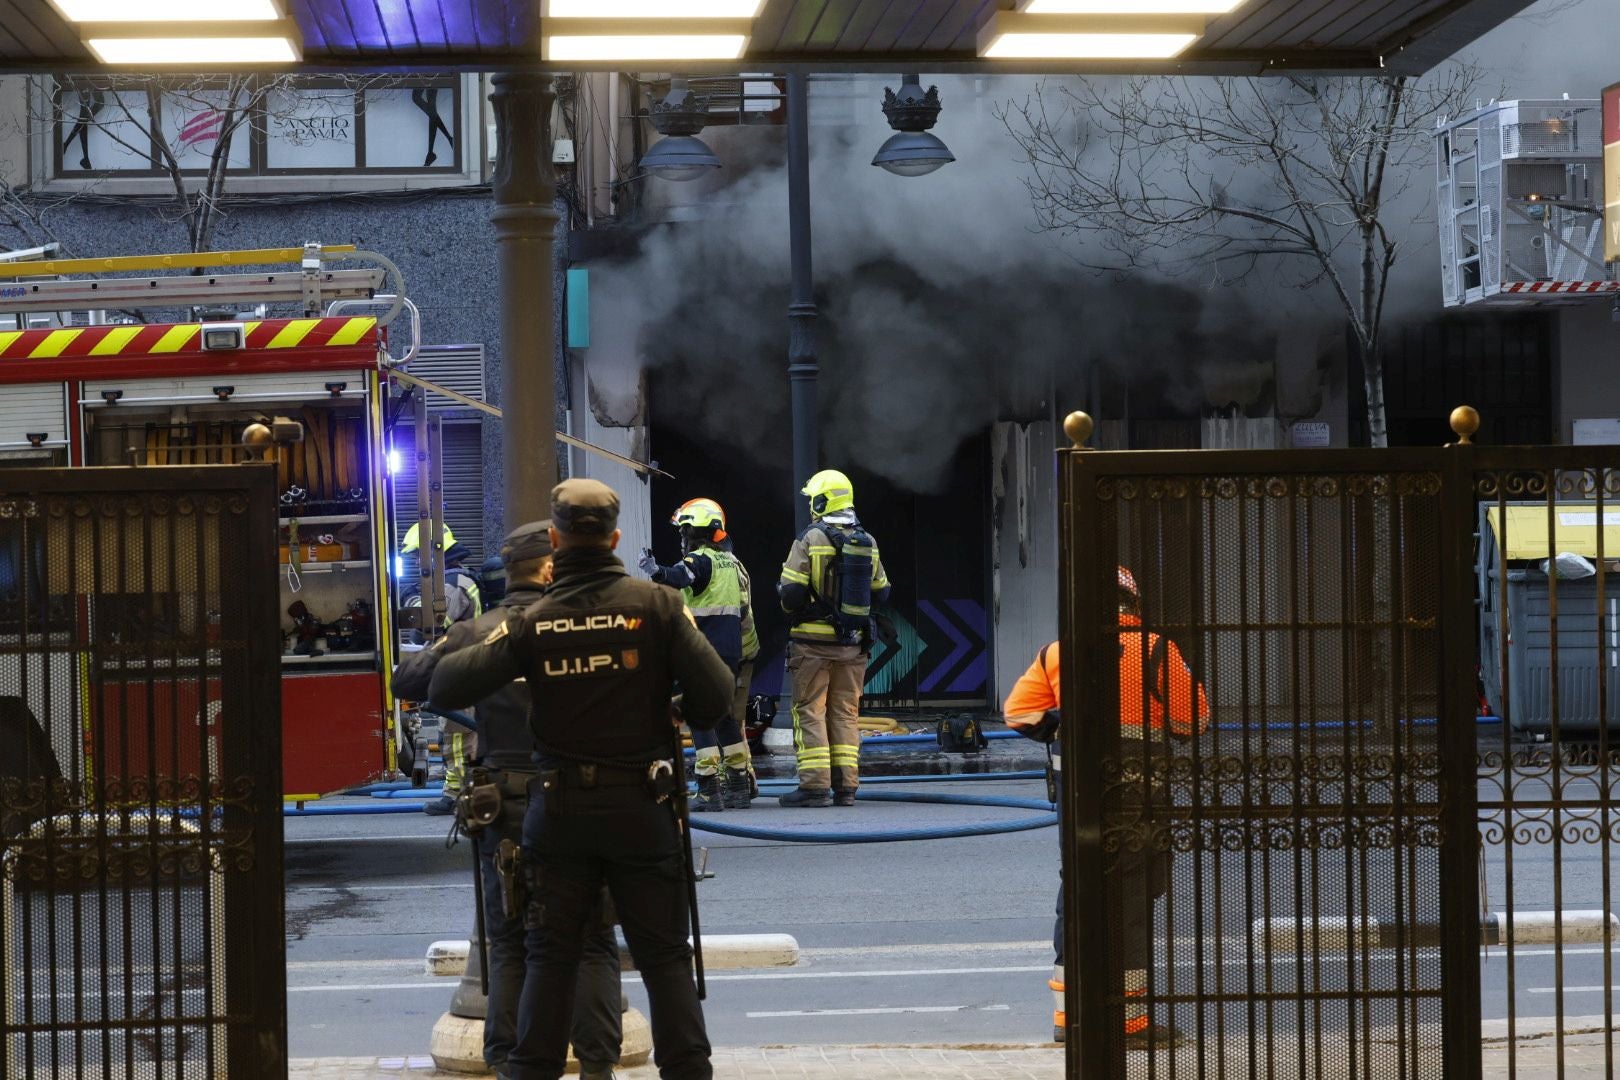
<box><xmin>431</xmin><ymin>479</ymin><xmax>732</xmax><ymax>1080</ymax></box>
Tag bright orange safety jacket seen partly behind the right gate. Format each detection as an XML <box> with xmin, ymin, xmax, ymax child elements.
<box><xmin>1001</xmin><ymin>612</ymin><xmax>1210</xmax><ymax>742</ymax></box>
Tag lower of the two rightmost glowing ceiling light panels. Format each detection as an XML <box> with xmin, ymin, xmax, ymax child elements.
<box><xmin>978</xmin><ymin>11</ymin><xmax>1204</xmax><ymax>60</ymax></box>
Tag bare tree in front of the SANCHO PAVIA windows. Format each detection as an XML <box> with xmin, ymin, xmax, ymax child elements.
<box><xmin>45</xmin><ymin>74</ymin><xmax>382</xmax><ymax>251</ymax></box>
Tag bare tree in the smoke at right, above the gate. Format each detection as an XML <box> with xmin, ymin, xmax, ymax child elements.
<box><xmin>1001</xmin><ymin>65</ymin><xmax>1476</xmax><ymax>447</ymax></box>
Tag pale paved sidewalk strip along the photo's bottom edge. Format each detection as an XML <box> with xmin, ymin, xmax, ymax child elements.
<box><xmin>292</xmin><ymin>1033</ymin><xmax>1620</xmax><ymax>1080</ymax></box>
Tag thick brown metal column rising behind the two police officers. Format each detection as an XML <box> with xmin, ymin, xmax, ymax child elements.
<box><xmin>489</xmin><ymin>71</ymin><xmax>557</xmax><ymax>529</ymax></box>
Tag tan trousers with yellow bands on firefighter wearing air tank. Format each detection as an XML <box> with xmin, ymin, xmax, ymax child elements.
<box><xmin>787</xmin><ymin>641</ymin><xmax>867</xmax><ymax>792</ymax></box>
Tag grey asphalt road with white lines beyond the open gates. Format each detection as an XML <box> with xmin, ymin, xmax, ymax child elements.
<box><xmin>287</xmin><ymin>782</ymin><xmax>1620</xmax><ymax>1057</ymax></box>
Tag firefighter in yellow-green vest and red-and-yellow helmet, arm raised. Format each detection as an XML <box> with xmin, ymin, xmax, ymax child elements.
<box><xmin>638</xmin><ymin>499</ymin><xmax>760</xmax><ymax>813</ymax></box>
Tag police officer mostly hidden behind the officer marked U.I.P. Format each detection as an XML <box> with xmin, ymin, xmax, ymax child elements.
<box><xmin>394</xmin><ymin>521</ymin><xmax>624</xmax><ymax>1080</ymax></box>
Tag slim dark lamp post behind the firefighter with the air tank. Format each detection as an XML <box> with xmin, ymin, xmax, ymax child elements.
<box><xmin>787</xmin><ymin>74</ymin><xmax>818</xmax><ymax>529</ymax></box>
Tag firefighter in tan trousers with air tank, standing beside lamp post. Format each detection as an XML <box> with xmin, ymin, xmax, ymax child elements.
<box><xmin>776</xmin><ymin>470</ymin><xmax>889</xmax><ymax>806</ymax></box>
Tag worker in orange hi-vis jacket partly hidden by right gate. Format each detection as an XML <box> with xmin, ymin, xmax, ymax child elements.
<box><xmin>1001</xmin><ymin>567</ymin><xmax>1210</xmax><ymax>1049</ymax></box>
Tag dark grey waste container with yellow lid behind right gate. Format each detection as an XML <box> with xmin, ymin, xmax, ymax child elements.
<box><xmin>1477</xmin><ymin>502</ymin><xmax>1620</xmax><ymax>737</ymax></box>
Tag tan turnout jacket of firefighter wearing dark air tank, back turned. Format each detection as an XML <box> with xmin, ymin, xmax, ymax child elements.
<box><xmin>776</xmin><ymin>512</ymin><xmax>889</xmax><ymax>644</ymax></box>
